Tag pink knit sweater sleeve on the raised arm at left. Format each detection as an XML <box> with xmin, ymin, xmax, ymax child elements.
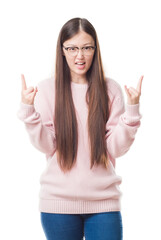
<box><xmin>17</xmin><ymin>80</ymin><xmax>56</xmax><ymax>155</ymax></box>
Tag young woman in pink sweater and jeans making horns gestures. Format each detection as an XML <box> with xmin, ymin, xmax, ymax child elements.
<box><xmin>18</xmin><ymin>18</ymin><xmax>143</xmax><ymax>240</ymax></box>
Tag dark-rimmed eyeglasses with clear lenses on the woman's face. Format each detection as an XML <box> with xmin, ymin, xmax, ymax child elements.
<box><xmin>63</xmin><ymin>46</ymin><xmax>96</xmax><ymax>57</ymax></box>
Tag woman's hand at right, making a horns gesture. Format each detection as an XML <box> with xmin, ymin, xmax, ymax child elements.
<box><xmin>125</xmin><ymin>76</ymin><xmax>144</xmax><ymax>105</ymax></box>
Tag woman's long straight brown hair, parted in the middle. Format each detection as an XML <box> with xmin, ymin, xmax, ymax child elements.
<box><xmin>54</xmin><ymin>18</ymin><xmax>109</xmax><ymax>172</ymax></box>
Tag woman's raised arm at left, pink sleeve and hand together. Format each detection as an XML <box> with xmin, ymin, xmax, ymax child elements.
<box><xmin>17</xmin><ymin>75</ymin><xmax>56</xmax><ymax>155</ymax></box>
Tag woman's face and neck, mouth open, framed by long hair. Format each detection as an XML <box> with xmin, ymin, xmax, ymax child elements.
<box><xmin>63</xmin><ymin>31</ymin><xmax>95</xmax><ymax>81</ymax></box>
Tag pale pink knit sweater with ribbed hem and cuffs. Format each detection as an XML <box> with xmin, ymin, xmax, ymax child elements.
<box><xmin>17</xmin><ymin>78</ymin><xmax>141</xmax><ymax>214</ymax></box>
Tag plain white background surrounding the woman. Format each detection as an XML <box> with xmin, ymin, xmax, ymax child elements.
<box><xmin>0</xmin><ymin>0</ymin><xmax>161</xmax><ymax>240</ymax></box>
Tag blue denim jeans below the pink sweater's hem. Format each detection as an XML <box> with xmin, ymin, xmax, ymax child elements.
<box><xmin>41</xmin><ymin>211</ymin><xmax>123</xmax><ymax>240</ymax></box>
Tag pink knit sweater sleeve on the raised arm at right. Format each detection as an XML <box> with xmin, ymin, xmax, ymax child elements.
<box><xmin>105</xmin><ymin>85</ymin><xmax>141</xmax><ymax>158</ymax></box>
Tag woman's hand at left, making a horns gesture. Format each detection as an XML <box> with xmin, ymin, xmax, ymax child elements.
<box><xmin>21</xmin><ymin>74</ymin><xmax>38</xmax><ymax>105</ymax></box>
